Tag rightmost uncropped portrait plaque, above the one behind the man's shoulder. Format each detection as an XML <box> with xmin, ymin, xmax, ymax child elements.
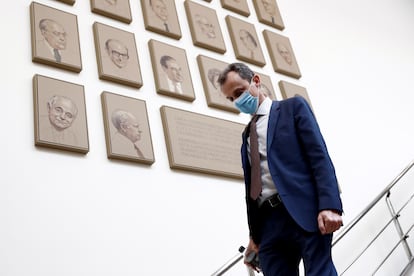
<box><xmin>263</xmin><ymin>30</ymin><xmax>301</xmax><ymax>79</ymax></box>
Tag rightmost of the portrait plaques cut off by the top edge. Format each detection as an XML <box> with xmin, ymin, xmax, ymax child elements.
<box><xmin>253</xmin><ymin>0</ymin><xmax>285</xmax><ymax>30</ymax></box>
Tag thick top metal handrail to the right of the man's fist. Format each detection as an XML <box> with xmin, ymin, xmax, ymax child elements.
<box><xmin>332</xmin><ymin>160</ymin><xmax>414</xmax><ymax>246</ymax></box>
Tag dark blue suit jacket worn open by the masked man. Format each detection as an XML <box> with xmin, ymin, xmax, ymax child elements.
<box><xmin>241</xmin><ymin>97</ymin><xmax>342</xmax><ymax>242</ymax></box>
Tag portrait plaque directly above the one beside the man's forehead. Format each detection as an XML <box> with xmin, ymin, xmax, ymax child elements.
<box><xmin>184</xmin><ymin>0</ymin><xmax>226</xmax><ymax>54</ymax></box>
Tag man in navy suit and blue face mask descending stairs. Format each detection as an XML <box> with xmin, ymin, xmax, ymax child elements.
<box><xmin>219</xmin><ymin>63</ymin><xmax>342</xmax><ymax>276</ymax></box>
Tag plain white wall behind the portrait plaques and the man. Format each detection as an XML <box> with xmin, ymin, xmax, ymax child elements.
<box><xmin>0</xmin><ymin>0</ymin><xmax>414</xmax><ymax>276</ymax></box>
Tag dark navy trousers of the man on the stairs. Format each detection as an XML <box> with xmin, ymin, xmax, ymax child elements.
<box><xmin>259</xmin><ymin>205</ymin><xmax>338</xmax><ymax>276</ymax></box>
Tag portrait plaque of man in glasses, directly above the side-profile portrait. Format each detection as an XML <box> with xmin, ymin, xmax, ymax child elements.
<box><xmin>93</xmin><ymin>22</ymin><xmax>142</xmax><ymax>88</ymax></box>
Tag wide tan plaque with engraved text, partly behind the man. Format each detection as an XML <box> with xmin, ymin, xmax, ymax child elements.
<box><xmin>160</xmin><ymin>106</ymin><xmax>245</xmax><ymax>179</ymax></box>
